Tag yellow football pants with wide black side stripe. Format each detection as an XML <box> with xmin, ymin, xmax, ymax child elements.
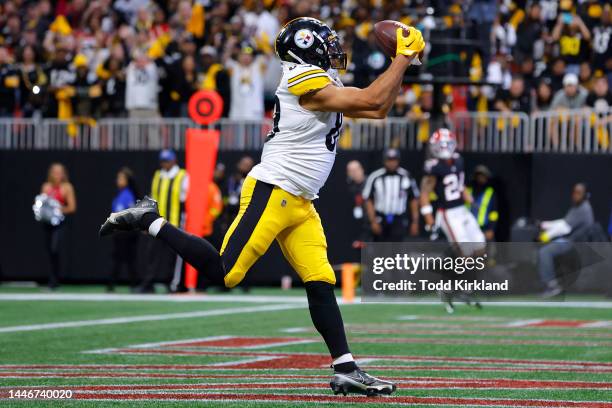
<box><xmin>221</xmin><ymin>177</ymin><xmax>336</xmax><ymax>288</ymax></box>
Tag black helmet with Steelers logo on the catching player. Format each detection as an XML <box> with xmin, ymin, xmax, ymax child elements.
<box><xmin>276</xmin><ymin>17</ymin><xmax>346</xmax><ymax>71</ymax></box>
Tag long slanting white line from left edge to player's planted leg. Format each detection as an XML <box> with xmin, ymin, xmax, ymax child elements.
<box><xmin>0</xmin><ymin>304</ymin><xmax>303</xmax><ymax>333</ymax></box>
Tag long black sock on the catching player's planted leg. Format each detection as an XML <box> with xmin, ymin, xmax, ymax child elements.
<box><xmin>304</xmin><ymin>282</ymin><xmax>357</xmax><ymax>372</ymax></box>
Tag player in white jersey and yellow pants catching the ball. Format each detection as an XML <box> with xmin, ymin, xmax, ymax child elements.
<box><xmin>100</xmin><ymin>17</ymin><xmax>425</xmax><ymax>395</ymax></box>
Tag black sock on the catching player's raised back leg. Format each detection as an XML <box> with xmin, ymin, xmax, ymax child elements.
<box><xmin>157</xmin><ymin>222</ymin><xmax>225</xmax><ymax>285</ymax></box>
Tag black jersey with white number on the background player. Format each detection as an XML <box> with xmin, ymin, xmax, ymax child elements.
<box><xmin>425</xmin><ymin>153</ymin><xmax>465</xmax><ymax>208</ymax></box>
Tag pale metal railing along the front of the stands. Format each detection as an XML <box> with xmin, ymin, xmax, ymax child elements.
<box><xmin>0</xmin><ymin>109</ymin><xmax>612</xmax><ymax>154</ymax></box>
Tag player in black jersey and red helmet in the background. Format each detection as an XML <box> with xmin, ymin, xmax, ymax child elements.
<box><xmin>420</xmin><ymin>128</ymin><xmax>486</xmax><ymax>313</ymax></box>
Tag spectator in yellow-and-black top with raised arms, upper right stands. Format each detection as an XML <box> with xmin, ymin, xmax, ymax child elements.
<box><xmin>551</xmin><ymin>11</ymin><xmax>591</xmax><ymax>74</ymax></box>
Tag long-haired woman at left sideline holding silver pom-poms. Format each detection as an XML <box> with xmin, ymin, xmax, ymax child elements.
<box><xmin>40</xmin><ymin>163</ymin><xmax>76</xmax><ymax>290</ymax></box>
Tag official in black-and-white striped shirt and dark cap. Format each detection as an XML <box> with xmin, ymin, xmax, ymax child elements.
<box><xmin>363</xmin><ymin>149</ymin><xmax>419</xmax><ymax>242</ymax></box>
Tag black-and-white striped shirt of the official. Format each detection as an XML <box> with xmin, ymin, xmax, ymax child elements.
<box><xmin>363</xmin><ymin>167</ymin><xmax>420</xmax><ymax>215</ymax></box>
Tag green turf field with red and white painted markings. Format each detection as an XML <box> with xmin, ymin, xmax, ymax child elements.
<box><xmin>0</xmin><ymin>287</ymin><xmax>612</xmax><ymax>407</ymax></box>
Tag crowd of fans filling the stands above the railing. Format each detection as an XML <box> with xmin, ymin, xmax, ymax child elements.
<box><xmin>0</xmin><ymin>0</ymin><xmax>612</xmax><ymax>120</ymax></box>
